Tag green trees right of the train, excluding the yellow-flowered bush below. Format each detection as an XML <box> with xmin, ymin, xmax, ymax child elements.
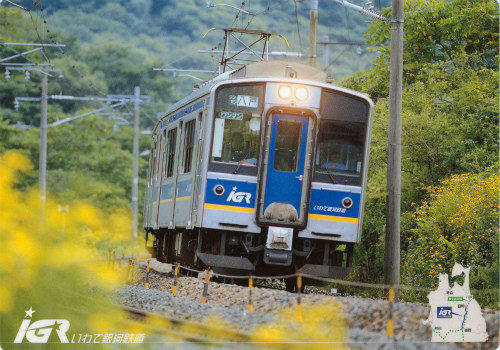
<box><xmin>344</xmin><ymin>0</ymin><xmax>498</xmax><ymax>292</ymax></box>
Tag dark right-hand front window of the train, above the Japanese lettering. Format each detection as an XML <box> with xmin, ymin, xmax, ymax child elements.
<box><xmin>313</xmin><ymin>92</ymin><xmax>368</xmax><ymax>186</ymax></box>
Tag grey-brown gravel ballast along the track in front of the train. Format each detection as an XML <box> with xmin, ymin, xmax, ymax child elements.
<box><xmin>113</xmin><ymin>260</ymin><xmax>499</xmax><ymax>350</ymax></box>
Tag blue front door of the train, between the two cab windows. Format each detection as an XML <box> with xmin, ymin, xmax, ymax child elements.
<box><xmin>258</xmin><ymin>114</ymin><xmax>314</xmax><ymax>227</ymax></box>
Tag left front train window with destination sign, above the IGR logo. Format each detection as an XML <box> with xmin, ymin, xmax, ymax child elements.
<box><xmin>211</xmin><ymin>85</ymin><xmax>264</xmax><ymax>174</ymax></box>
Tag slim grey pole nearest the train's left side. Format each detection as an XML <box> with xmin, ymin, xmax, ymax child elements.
<box><xmin>132</xmin><ymin>86</ymin><xmax>141</xmax><ymax>244</ymax></box>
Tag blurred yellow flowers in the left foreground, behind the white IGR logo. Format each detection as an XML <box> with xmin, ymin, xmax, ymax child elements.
<box><xmin>0</xmin><ymin>152</ymin><xmax>143</xmax><ymax>348</ymax></box>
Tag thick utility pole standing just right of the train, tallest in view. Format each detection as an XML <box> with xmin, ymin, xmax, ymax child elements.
<box><xmin>384</xmin><ymin>0</ymin><xmax>404</xmax><ymax>300</ymax></box>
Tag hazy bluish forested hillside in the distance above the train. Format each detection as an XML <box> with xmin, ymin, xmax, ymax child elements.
<box><xmin>43</xmin><ymin>0</ymin><xmax>390</xmax><ymax>82</ymax></box>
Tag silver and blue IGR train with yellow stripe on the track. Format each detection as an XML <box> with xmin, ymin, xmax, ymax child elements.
<box><xmin>143</xmin><ymin>51</ymin><xmax>373</xmax><ymax>290</ymax></box>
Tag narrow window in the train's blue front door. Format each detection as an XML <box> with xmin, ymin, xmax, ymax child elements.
<box><xmin>274</xmin><ymin>119</ymin><xmax>302</xmax><ymax>172</ymax></box>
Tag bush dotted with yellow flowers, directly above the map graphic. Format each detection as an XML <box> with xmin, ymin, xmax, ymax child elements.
<box><xmin>403</xmin><ymin>174</ymin><xmax>499</xmax><ymax>307</ymax></box>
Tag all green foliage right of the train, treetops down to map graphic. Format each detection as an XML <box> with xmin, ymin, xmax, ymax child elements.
<box><xmin>344</xmin><ymin>0</ymin><xmax>499</xmax><ymax>308</ymax></box>
